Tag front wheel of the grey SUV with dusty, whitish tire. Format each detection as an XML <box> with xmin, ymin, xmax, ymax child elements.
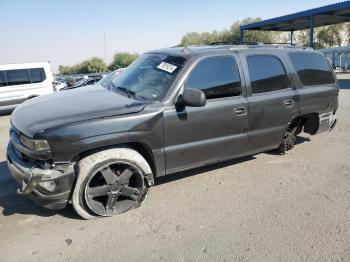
<box><xmin>72</xmin><ymin>147</ymin><xmax>152</xmax><ymax>219</ymax></box>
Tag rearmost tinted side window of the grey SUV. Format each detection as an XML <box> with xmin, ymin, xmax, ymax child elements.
<box><xmin>290</xmin><ymin>53</ymin><xmax>335</xmax><ymax>86</ymax></box>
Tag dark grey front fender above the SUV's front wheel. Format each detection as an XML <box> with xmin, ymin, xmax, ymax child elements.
<box><xmin>40</xmin><ymin>107</ymin><xmax>163</xmax><ymax>163</ymax></box>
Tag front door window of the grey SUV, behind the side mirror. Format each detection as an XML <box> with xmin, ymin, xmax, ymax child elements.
<box><xmin>185</xmin><ymin>56</ymin><xmax>241</xmax><ymax>99</ymax></box>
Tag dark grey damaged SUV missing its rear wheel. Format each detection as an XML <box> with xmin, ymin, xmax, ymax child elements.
<box><xmin>7</xmin><ymin>45</ymin><xmax>339</xmax><ymax>219</ymax></box>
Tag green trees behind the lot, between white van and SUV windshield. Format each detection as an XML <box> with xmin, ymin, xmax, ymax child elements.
<box><xmin>58</xmin><ymin>57</ymin><xmax>107</xmax><ymax>75</ymax></box>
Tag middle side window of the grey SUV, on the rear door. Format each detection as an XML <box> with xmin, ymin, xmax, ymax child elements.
<box><xmin>247</xmin><ymin>55</ymin><xmax>289</xmax><ymax>94</ymax></box>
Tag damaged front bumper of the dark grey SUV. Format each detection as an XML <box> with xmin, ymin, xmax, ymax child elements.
<box><xmin>7</xmin><ymin>142</ymin><xmax>75</xmax><ymax>209</ymax></box>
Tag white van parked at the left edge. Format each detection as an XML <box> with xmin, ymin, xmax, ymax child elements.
<box><xmin>0</xmin><ymin>62</ymin><xmax>54</xmax><ymax>109</ymax></box>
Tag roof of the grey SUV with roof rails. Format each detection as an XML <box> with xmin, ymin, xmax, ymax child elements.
<box><xmin>147</xmin><ymin>43</ymin><xmax>312</xmax><ymax>58</ymax></box>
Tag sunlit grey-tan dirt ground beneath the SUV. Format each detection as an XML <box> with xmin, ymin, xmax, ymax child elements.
<box><xmin>0</xmin><ymin>89</ymin><xmax>350</xmax><ymax>262</ymax></box>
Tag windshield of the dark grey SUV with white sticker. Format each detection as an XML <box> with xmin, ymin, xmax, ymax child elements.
<box><xmin>110</xmin><ymin>54</ymin><xmax>185</xmax><ymax>101</ymax></box>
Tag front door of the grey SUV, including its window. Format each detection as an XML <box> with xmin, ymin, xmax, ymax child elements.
<box><xmin>164</xmin><ymin>54</ymin><xmax>248</xmax><ymax>173</ymax></box>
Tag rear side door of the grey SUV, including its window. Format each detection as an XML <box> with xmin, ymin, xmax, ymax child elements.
<box><xmin>243</xmin><ymin>53</ymin><xmax>299</xmax><ymax>153</ymax></box>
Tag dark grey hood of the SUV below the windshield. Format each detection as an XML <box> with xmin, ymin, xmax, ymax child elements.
<box><xmin>11</xmin><ymin>85</ymin><xmax>145</xmax><ymax>137</ymax></box>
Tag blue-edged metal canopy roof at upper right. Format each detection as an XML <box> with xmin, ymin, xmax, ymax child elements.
<box><xmin>240</xmin><ymin>1</ymin><xmax>350</xmax><ymax>31</ymax></box>
